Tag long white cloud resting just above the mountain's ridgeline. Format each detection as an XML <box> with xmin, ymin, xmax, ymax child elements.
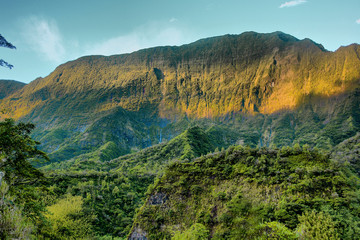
<box><xmin>85</xmin><ymin>23</ymin><xmax>193</xmax><ymax>55</ymax></box>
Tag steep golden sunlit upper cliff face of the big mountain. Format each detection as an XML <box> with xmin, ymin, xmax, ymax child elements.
<box><xmin>3</xmin><ymin>32</ymin><xmax>360</xmax><ymax>118</ymax></box>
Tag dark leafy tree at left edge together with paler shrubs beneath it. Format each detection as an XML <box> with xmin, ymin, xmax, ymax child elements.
<box><xmin>0</xmin><ymin>119</ymin><xmax>48</xmax><ymax>239</ymax></box>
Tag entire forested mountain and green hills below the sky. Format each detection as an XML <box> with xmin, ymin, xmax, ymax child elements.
<box><xmin>0</xmin><ymin>32</ymin><xmax>360</xmax><ymax>240</ymax></box>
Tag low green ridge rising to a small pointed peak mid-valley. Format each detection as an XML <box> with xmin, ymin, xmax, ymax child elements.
<box><xmin>42</xmin><ymin>126</ymin><xmax>215</xmax><ymax>176</ymax></box>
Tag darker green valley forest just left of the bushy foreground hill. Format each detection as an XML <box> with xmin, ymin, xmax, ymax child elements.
<box><xmin>43</xmin><ymin>172</ymin><xmax>154</xmax><ymax>237</ymax></box>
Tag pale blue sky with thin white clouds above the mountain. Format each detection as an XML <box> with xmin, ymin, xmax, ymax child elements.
<box><xmin>0</xmin><ymin>0</ymin><xmax>360</xmax><ymax>83</ymax></box>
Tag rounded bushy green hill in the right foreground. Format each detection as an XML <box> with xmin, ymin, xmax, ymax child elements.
<box><xmin>129</xmin><ymin>143</ymin><xmax>360</xmax><ymax>239</ymax></box>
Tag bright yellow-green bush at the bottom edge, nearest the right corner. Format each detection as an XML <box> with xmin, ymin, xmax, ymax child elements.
<box><xmin>296</xmin><ymin>211</ymin><xmax>340</xmax><ymax>240</ymax></box>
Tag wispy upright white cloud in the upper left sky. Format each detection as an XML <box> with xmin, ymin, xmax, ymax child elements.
<box><xmin>22</xmin><ymin>16</ymin><xmax>65</xmax><ymax>63</ymax></box>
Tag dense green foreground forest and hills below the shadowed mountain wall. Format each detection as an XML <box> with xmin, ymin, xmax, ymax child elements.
<box><xmin>0</xmin><ymin>120</ymin><xmax>360</xmax><ymax>239</ymax></box>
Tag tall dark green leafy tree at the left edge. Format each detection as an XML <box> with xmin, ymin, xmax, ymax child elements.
<box><xmin>0</xmin><ymin>119</ymin><xmax>49</xmax><ymax>232</ymax></box>
